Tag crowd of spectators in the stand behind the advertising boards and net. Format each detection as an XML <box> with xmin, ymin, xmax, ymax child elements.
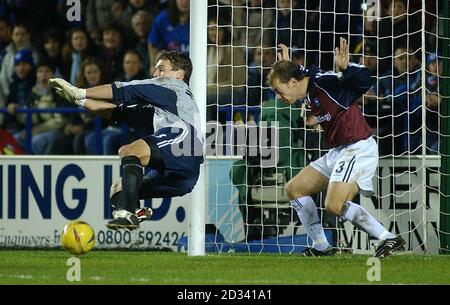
<box><xmin>0</xmin><ymin>0</ymin><xmax>442</xmax><ymax>155</ymax></box>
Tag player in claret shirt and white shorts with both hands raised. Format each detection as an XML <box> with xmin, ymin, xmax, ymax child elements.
<box><xmin>267</xmin><ymin>38</ymin><xmax>405</xmax><ymax>257</ymax></box>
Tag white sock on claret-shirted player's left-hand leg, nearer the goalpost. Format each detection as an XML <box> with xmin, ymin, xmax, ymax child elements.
<box><xmin>291</xmin><ymin>196</ymin><xmax>330</xmax><ymax>251</ymax></box>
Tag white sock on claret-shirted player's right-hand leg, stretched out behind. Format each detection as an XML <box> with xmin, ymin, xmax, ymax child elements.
<box><xmin>342</xmin><ymin>201</ymin><xmax>395</xmax><ymax>240</ymax></box>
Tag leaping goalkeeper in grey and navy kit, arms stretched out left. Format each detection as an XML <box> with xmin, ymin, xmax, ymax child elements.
<box><xmin>49</xmin><ymin>51</ymin><xmax>203</xmax><ymax>230</ymax></box>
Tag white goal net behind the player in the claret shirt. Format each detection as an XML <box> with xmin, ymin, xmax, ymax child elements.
<box><xmin>206</xmin><ymin>0</ymin><xmax>450</xmax><ymax>253</ymax></box>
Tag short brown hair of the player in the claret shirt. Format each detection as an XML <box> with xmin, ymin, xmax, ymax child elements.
<box><xmin>267</xmin><ymin>60</ymin><xmax>308</xmax><ymax>87</ymax></box>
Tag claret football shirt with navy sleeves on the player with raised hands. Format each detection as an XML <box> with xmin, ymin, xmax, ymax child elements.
<box><xmin>305</xmin><ymin>63</ymin><xmax>373</xmax><ymax>148</ymax></box>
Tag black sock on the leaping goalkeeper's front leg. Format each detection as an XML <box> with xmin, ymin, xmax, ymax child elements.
<box><xmin>122</xmin><ymin>156</ymin><xmax>143</xmax><ymax>214</ymax></box>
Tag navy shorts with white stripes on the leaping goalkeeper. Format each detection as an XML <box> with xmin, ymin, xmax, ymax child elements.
<box><xmin>139</xmin><ymin>127</ymin><xmax>203</xmax><ymax>199</ymax></box>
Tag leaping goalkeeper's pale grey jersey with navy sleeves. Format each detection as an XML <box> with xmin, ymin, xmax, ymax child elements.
<box><xmin>112</xmin><ymin>77</ymin><xmax>204</xmax><ymax>151</ymax></box>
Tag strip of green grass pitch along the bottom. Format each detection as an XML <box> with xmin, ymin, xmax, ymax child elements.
<box><xmin>0</xmin><ymin>250</ymin><xmax>450</xmax><ymax>285</ymax></box>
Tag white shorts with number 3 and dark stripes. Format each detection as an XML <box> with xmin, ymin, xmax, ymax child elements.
<box><xmin>310</xmin><ymin>137</ymin><xmax>378</xmax><ymax>197</ymax></box>
